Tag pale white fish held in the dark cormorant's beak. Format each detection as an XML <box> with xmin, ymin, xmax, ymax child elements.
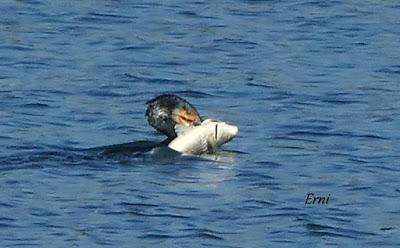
<box><xmin>168</xmin><ymin>119</ymin><xmax>239</xmax><ymax>154</ymax></box>
